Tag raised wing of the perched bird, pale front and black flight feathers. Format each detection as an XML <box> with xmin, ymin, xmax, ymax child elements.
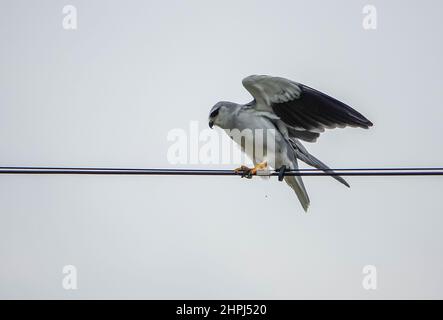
<box><xmin>243</xmin><ymin>75</ymin><xmax>372</xmax><ymax>133</ymax></box>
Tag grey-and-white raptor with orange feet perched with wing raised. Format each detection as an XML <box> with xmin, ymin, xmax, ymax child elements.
<box><xmin>209</xmin><ymin>75</ymin><xmax>372</xmax><ymax>211</ymax></box>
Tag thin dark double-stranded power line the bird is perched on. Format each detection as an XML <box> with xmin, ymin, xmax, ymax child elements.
<box><xmin>0</xmin><ymin>167</ymin><xmax>443</xmax><ymax>177</ymax></box>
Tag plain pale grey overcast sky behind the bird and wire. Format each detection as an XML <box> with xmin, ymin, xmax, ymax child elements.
<box><xmin>0</xmin><ymin>0</ymin><xmax>443</xmax><ymax>299</ymax></box>
